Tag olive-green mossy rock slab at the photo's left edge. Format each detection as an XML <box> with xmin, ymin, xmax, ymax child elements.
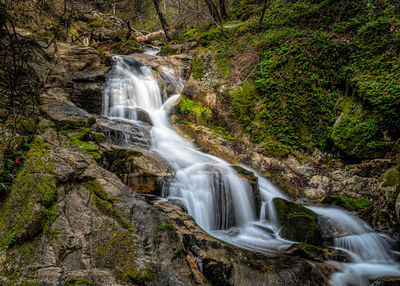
<box><xmin>0</xmin><ymin>137</ymin><xmax>58</xmax><ymax>248</ymax></box>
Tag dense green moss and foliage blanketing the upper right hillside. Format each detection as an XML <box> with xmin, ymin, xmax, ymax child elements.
<box><xmin>183</xmin><ymin>0</ymin><xmax>400</xmax><ymax>160</ymax></box>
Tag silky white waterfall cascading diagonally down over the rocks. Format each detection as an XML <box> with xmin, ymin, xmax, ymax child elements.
<box><xmin>102</xmin><ymin>56</ymin><xmax>400</xmax><ymax>285</ymax></box>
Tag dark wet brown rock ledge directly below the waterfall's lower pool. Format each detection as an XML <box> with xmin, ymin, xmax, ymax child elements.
<box><xmin>155</xmin><ymin>203</ymin><xmax>334</xmax><ymax>286</ymax></box>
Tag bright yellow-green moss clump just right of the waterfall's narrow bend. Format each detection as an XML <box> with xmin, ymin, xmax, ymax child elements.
<box><xmin>179</xmin><ymin>95</ymin><xmax>213</xmax><ymax>125</ymax></box>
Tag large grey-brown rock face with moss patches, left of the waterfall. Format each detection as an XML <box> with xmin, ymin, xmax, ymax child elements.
<box><xmin>0</xmin><ymin>33</ymin><xmax>333</xmax><ymax>285</ymax></box>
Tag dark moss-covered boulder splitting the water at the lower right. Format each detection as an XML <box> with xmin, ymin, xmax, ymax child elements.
<box><xmin>273</xmin><ymin>198</ymin><xmax>322</xmax><ymax>246</ymax></box>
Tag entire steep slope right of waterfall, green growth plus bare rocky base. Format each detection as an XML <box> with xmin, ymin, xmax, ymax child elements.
<box><xmin>172</xmin><ymin>1</ymin><xmax>400</xmax><ymax>237</ymax></box>
